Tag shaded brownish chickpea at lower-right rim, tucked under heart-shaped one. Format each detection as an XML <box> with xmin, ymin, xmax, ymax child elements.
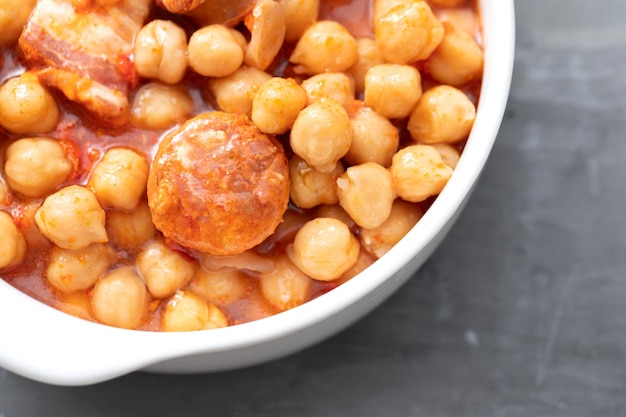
<box><xmin>359</xmin><ymin>199</ymin><xmax>423</xmax><ymax>258</ymax></box>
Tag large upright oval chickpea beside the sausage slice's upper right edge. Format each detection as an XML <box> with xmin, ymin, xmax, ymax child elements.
<box><xmin>289</xmin><ymin>98</ymin><xmax>352</xmax><ymax>173</ymax></box>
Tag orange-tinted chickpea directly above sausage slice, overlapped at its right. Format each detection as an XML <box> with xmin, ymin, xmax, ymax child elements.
<box><xmin>208</xmin><ymin>67</ymin><xmax>272</xmax><ymax>116</ymax></box>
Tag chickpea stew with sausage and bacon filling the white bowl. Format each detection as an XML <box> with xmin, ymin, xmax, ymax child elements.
<box><xmin>0</xmin><ymin>0</ymin><xmax>483</xmax><ymax>331</ymax></box>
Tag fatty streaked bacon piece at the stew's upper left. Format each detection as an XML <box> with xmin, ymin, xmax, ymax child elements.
<box><xmin>19</xmin><ymin>0</ymin><xmax>151</xmax><ymax>124</ymax></box>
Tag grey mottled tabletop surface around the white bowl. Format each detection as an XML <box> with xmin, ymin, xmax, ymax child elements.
<box><xmin>0</xmin><ymin>0</ymin><xmax>626</xmax><ymax>417</ymax></box>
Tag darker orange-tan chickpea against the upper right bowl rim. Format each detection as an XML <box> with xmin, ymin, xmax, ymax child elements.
<box><xmin>425</xmin><ymin>23</ymin><xmax>484</xmax><ymax>87</ymax></box>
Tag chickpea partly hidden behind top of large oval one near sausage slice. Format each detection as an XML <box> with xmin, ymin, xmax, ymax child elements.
<box><xmin>302</xmin><ymin>72</ymin><xmax>354</xmax><ymax>111</ymax></box>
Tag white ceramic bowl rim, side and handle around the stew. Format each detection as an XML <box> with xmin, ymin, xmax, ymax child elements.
<box><xmin>0</xmin><ymin>0</ymin><xmax>515</xmax><ymax>385</ymax></box>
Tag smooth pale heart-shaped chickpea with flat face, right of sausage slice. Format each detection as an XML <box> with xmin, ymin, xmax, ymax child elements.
<box><xmin>337</xmin><ymin>162</ymin><xmax>396</xmax><ymax>229</ymax></box>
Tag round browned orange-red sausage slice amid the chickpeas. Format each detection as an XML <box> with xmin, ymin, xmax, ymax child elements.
<box><xmin>148</xmin><ymin>112</ymin><xmax>289</xmax><ymax>255</ymax></box>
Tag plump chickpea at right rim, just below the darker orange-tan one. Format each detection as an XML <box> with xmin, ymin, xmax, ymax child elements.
<box><xmin>407</xmin><ymin>85</ymin><xmax>476</xmax><ymax>144</ymax></box>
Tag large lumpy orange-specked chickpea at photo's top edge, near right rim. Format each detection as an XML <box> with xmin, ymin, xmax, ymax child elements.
<box><xmin>374</xmin><ymin>0</ymin><xmax>444</xmax><ymax>64</ymax></box>
